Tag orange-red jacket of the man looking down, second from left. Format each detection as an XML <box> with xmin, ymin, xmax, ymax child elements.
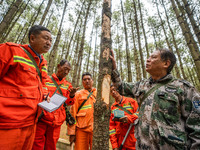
<box><xmin>41</xmin><ymin>73</ymin><xmax>75</xmax><ymax>126</ymax></box>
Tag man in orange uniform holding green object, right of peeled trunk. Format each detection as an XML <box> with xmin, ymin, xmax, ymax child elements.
<box><xmin>109</xmin><ymin>85</ymin><xmax>138</xmax><ymax>150</ymax></box>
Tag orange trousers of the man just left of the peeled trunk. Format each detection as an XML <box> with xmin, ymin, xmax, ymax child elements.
<box><xmin>75</xmin><ymin>128</ymin><xmax>93</xmax><ymax>150</ymax></box>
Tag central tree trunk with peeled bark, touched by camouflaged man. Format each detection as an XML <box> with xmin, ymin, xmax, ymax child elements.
<box><xmin>92</xmin><ymin>0</ymin><xmax>112</xmax><ymax>150</ymax></box>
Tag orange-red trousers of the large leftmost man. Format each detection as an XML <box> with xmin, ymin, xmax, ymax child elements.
<box><xmin>0</xmin><ymin>125</ymin><xmax>36</xmax><ymax>150</ymax></box>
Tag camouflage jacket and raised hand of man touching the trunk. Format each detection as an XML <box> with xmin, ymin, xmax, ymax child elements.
<box><xmin>112</xmin><ymin>70</ymin><xmax>200</xmax><ymax>150</ymax></box>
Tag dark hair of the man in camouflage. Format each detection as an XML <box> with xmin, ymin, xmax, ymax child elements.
<box><xmin>157</xmin><ymin>48</ymin><xmax>176</xmax><ymax>73</ymax></box>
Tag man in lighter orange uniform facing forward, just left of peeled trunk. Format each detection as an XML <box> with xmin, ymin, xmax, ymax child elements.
<box><xmin>67</xmin><ymin>72</ymin><xmax>97</xmax><ymax>150</ymax></box>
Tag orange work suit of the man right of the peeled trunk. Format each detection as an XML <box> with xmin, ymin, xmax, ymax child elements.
<box><xmin>109</xmin><ymin>97</ymin><xmax>138</xmax><ymax>149</ymax></box>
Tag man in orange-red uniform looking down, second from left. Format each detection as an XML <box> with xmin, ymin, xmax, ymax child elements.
<box><xmin>32</xmin><ymin>59</ymin><xmax>78</xmax><ymax>150</ymax></box>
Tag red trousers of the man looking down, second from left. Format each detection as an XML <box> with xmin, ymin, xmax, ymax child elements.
<box><xmin>32</xmin><ymin>121</ymin><xmax>61</xmax><ymax>150</ymax></box>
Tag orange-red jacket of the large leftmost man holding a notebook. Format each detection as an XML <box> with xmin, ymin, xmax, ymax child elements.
<box><xmin>0</xmin><ymin>42</ymin><xmax>47</xmax><ymax>129</ymax></box>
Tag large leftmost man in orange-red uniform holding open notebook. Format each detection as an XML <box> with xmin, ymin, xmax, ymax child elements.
<box><xmin>0</xmin><ymin>25</ymin><xmax>52</xmax><ymax>150</ymax></box>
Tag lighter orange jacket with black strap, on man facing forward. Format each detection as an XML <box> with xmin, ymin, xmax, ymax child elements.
<box><xmin>67</xmin><ymin>88</ymin><xmax>97</xmax><ymax>135</ymax></box>
